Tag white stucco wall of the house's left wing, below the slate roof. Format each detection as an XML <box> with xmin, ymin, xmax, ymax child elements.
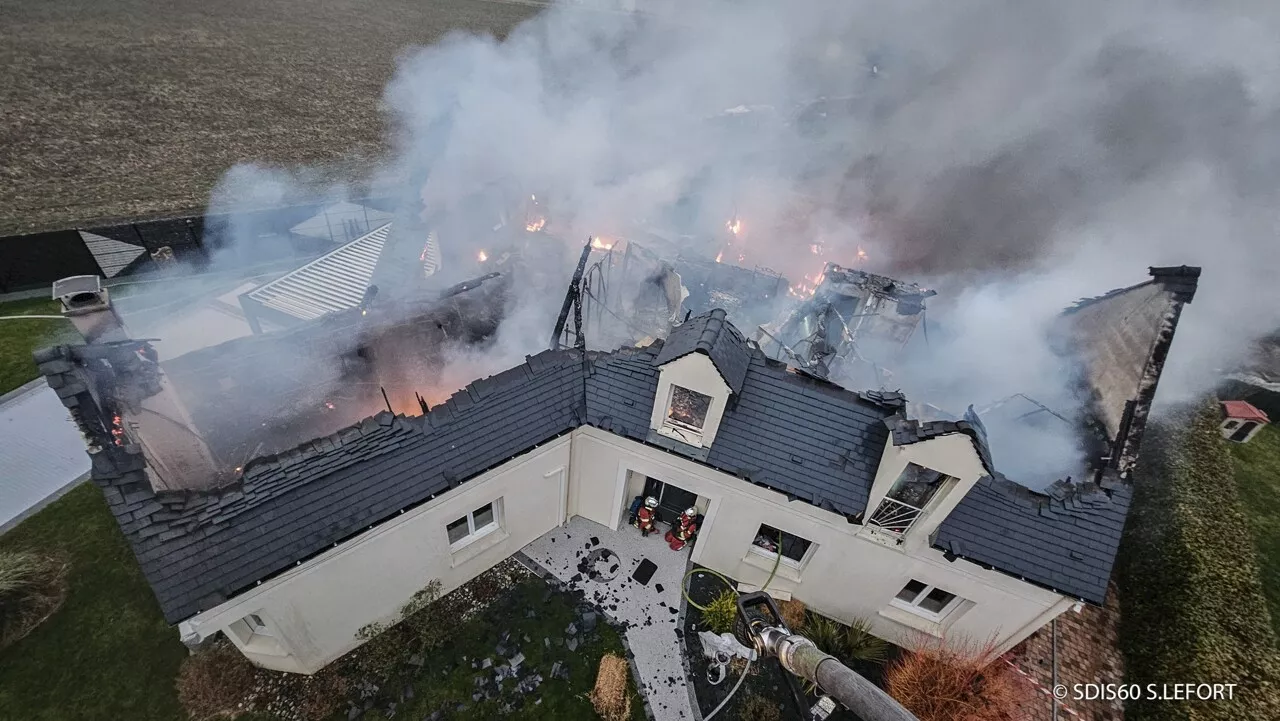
<box><xmin>183</xmin><ymin>435</ymin><xmax>570</xmax><ymax>674</ymax></box>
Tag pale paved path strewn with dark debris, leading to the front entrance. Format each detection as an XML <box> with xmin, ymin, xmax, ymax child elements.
<box><xmin>525</xmin><ymin>517</ymin><xmax>695</xmax><ymax>721</ymax></box>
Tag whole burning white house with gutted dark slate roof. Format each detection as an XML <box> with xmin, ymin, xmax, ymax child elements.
<box><xmin>36</xmin><ymin>242</ymin><xmax>1199</xmax><ymax>672</ymax></box>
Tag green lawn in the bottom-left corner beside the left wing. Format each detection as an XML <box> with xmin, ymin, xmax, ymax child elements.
<box><xmin>0</xmin><ymin>484</ymin><xmax>187</xmax><ymax>721</ymax></box>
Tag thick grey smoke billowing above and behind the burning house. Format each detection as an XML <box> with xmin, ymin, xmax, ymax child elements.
<box><xmin>199</xmin><ymin>0</ymin><xmax>1280</xmax><ymax>476</ymax></box>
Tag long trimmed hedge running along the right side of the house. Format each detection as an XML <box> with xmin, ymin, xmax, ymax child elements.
<box><xmin>1116</xmin><ymin>403</ymin><xmax>1280</xmax><ymax>721</ymax></box>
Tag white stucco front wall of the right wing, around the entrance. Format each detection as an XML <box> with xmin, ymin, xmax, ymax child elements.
<box><xmin>570</xmin><ymin>428</ymin><xmax>1071</xmax><ymax>651</ymax></box>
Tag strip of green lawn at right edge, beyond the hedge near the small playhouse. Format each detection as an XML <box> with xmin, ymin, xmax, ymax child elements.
<box><xmin>1230</xmin><ymin>425</ymin><xmax>1280</xmax><ymax>634</ymax></box>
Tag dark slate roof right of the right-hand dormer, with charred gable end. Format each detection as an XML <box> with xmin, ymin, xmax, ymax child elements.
<box><xmin>933</xmin><ymin>266</ymin><xmax>1199</xmax><ymax>604</ymax></box>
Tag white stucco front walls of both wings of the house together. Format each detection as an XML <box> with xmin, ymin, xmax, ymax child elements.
<box><xmin>189</xmin><ymin>428</ymin><xmax>1073</xmax><ymax>674</ymax></box>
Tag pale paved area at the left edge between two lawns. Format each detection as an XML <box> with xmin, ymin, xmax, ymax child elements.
<box><xmin>0</xmin><ymin>379</ymin><xmax>88</xmax><ymax>533</ymax></box>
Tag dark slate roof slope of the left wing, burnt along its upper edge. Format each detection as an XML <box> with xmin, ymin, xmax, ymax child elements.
<box><xmin>42</xmin><ymin>348</ymin><xmax>582</xmax><ymax>624</ymax></box>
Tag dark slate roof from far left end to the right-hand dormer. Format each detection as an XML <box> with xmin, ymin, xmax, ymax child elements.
<box><xmin>40</xmin><ymin>311</ymin><xmax>902</xmax><ymax>622</ymax></box>
